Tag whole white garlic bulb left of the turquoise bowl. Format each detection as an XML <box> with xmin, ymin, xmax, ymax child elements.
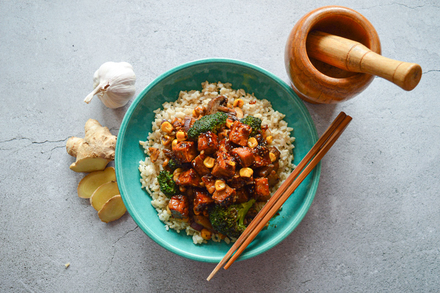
<box><xmin>84</xmin><ymin>62</ymin><xmax>136</xmax><ymax>109</ymax></box>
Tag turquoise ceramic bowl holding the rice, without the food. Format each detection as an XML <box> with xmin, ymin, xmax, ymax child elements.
<box><xmin>115</xmin><ymin>59</ymin><xmax>321</xmax><ymax>262</ymax></box>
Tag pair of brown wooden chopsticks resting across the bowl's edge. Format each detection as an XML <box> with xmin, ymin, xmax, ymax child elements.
<box><xmin>207</xmin><ymin>112</ymin><xmax>352</xmax><ymax>281</ymax></box>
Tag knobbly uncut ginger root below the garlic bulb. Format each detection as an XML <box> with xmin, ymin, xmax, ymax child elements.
<box><xmin>66</xmin><ymin>119</ymin><xmax>116</xmax><ymax>173</ymax></box>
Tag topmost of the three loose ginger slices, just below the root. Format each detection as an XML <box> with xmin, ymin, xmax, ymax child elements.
<box><xmin>78</xmin><ymin>167</ymin><xmax>116</xmax><ymax>198</ymax></box>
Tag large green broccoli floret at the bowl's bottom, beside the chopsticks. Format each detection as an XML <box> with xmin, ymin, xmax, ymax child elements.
<box><xmin>209</xmin><ymin>199</ymin><xmax>255</xmax><ymax>238</ymax></box>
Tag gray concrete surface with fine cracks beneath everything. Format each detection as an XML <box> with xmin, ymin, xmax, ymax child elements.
<box><xmin>0</xmin><ymin>0</ymin><xmax>440</xmax><ymax>292</ymax></box>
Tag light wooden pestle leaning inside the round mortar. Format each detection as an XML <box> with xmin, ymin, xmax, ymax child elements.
<box><xmin>307</xmin><ymin>31</ymin><xmax>422</xmax><ymax>91</ymax></box>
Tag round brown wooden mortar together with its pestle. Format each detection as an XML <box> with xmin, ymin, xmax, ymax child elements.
<box><xmin>285</xmin><ymin>6</ymin><xmax>421</xmax><ymax>104</ymax></box>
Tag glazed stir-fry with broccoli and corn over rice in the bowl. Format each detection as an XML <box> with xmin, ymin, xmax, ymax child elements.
<box><xmin>140</xmin><ymin>83</ymin><xmax>293</xmax><ymax>243</ymax></box>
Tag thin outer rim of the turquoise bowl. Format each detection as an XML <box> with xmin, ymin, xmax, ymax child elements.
<box><xmin>115</xmin><ymin>58</ymin><xmax>321</xmax><ymax>263</ymax></box>
